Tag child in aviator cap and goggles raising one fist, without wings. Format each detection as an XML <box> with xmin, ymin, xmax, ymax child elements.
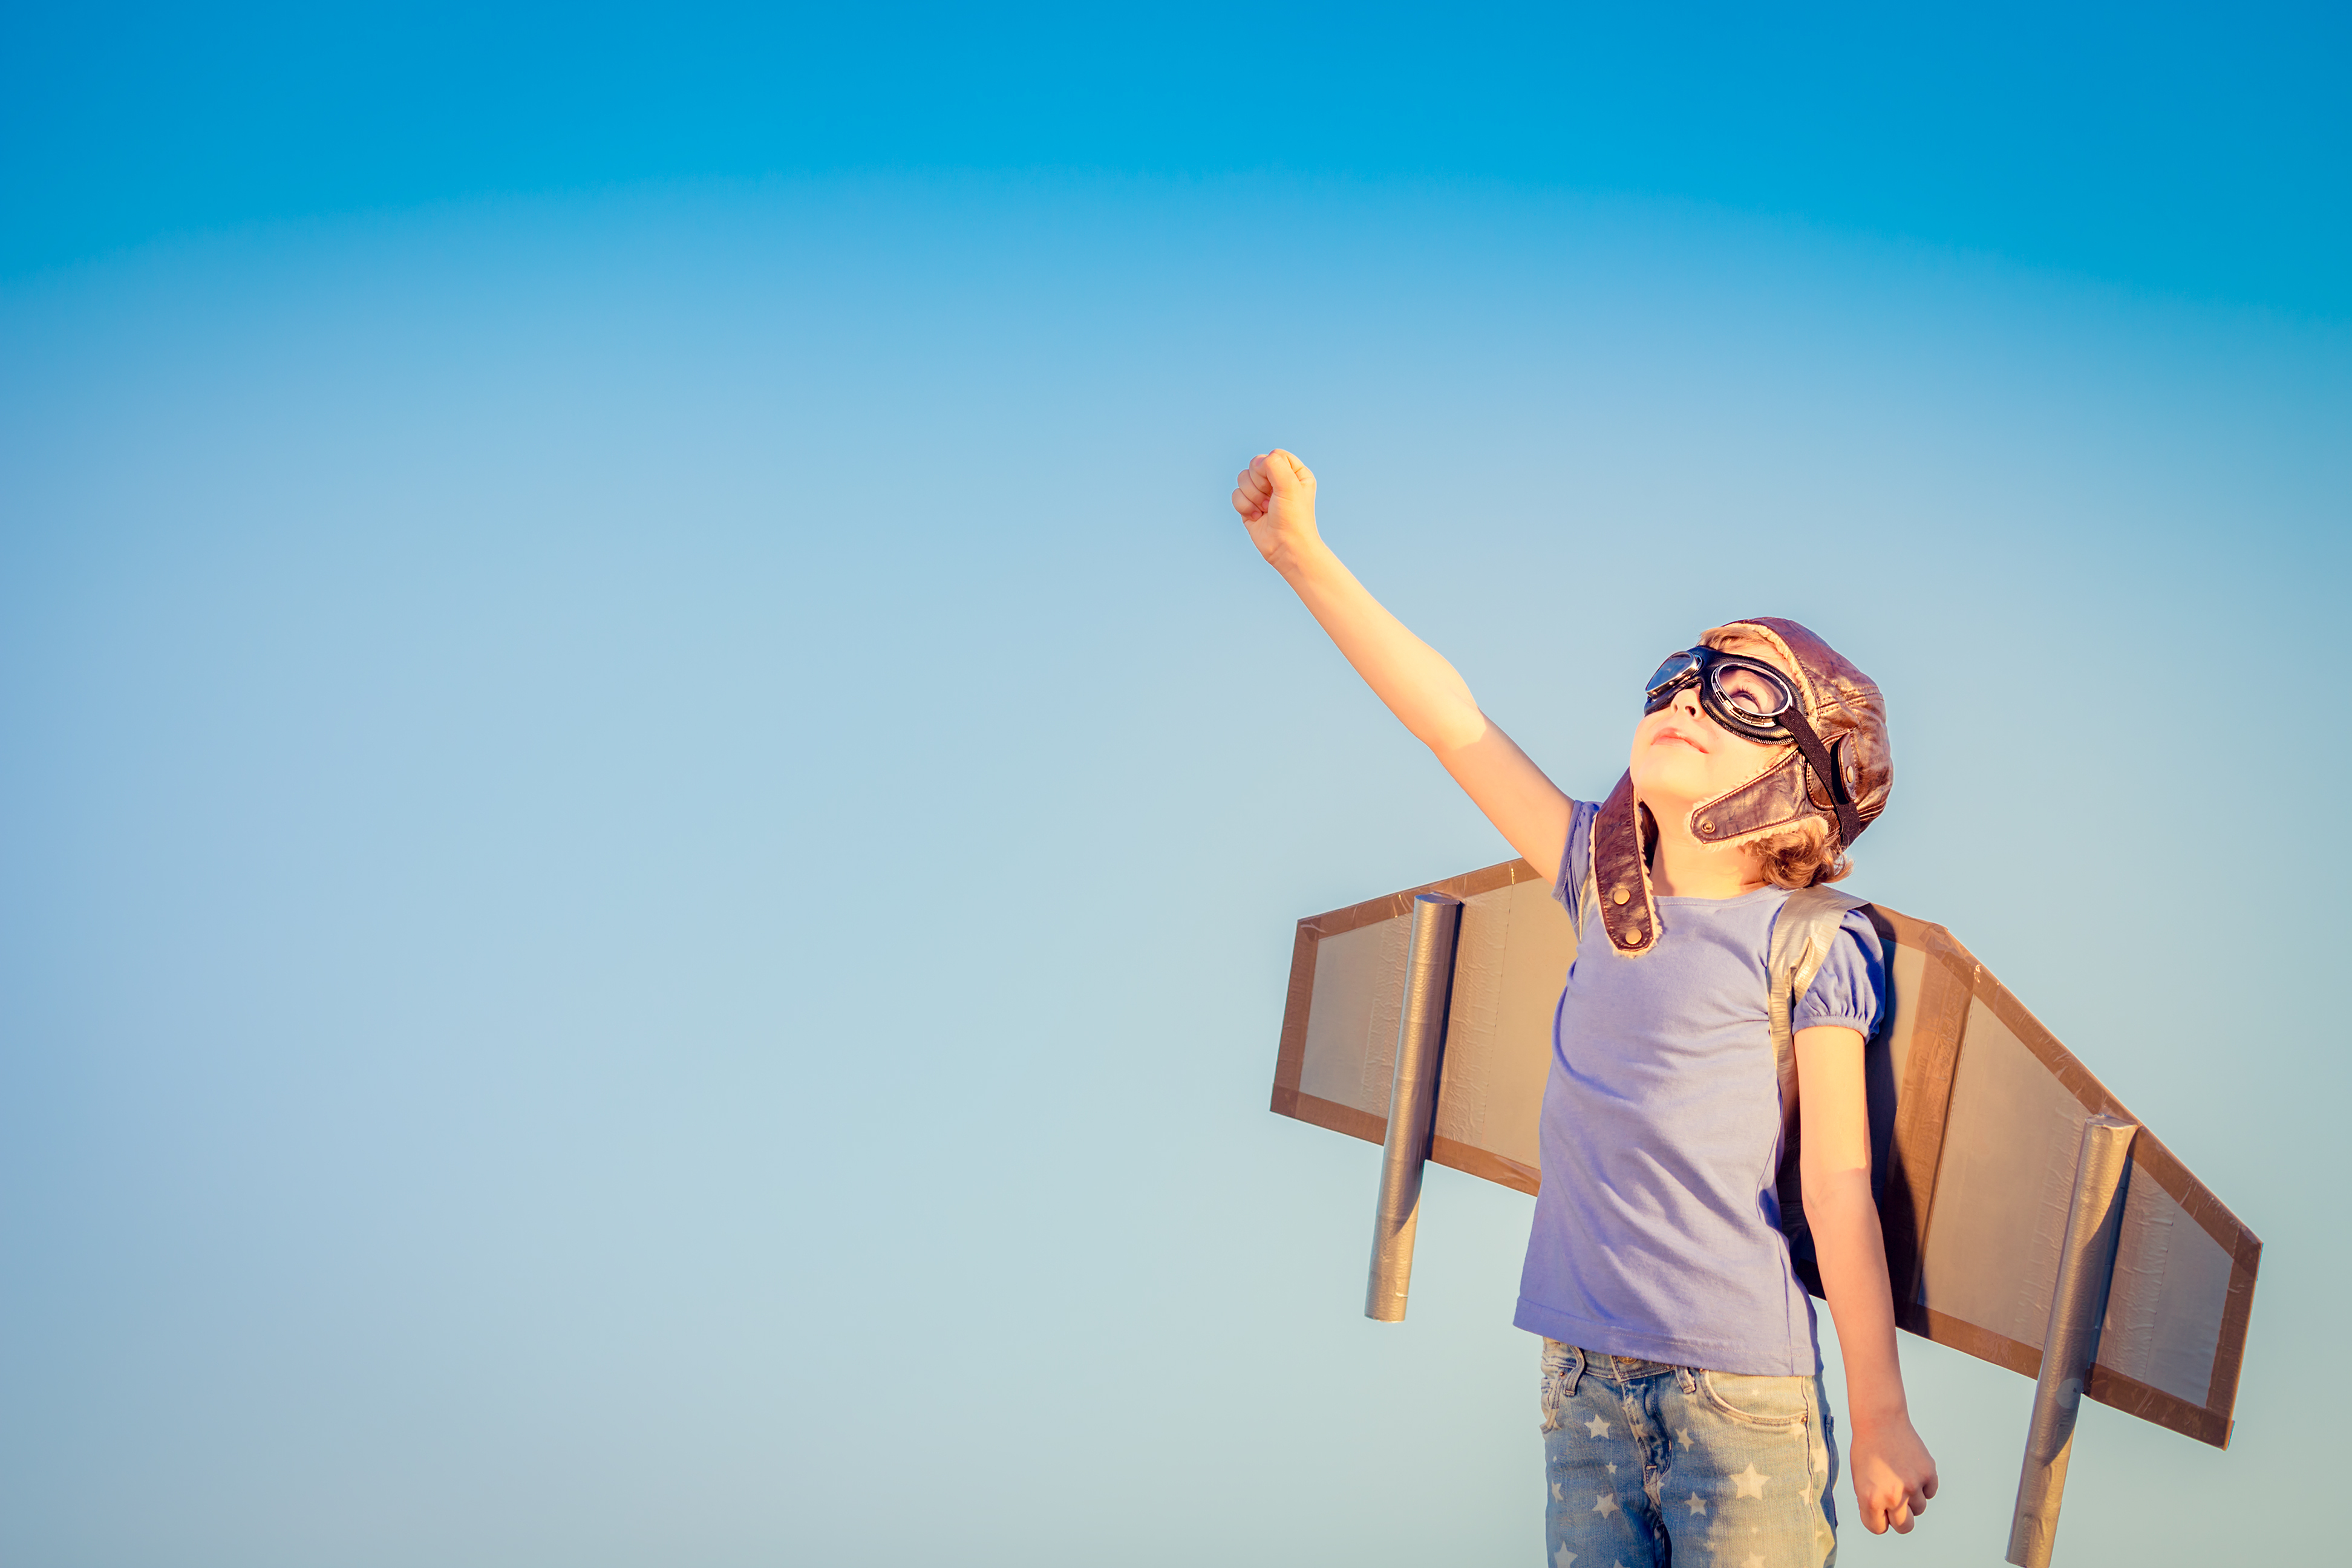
<box><xmin>1232</xmin><ymin>449</ymin><xmax>1936</xmax><ymax>1568</ymax></box>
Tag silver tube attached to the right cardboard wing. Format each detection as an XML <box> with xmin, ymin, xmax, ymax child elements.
<box><xmin>2008</xmin><ymin>1117</ymin><xmax>2140</xmax><ymax>1568</ymax></box>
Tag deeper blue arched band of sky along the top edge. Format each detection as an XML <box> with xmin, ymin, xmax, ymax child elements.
<box><xmin>13</xmin><ymin>5</ymin><xmax>2352</xmax><ymax>315</ymax></box>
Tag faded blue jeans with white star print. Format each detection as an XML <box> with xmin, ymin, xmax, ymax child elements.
<box><xmin>1543</xmin><ymin>1340</ymin><xmax>1837</xmax><ymax>1568</ymax></box>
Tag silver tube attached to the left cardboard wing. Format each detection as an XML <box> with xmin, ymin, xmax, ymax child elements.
<box><xmin>1364</xmin><ymin>893</ymin><xmax>1463</xmax><ymax>1324</ymax></box>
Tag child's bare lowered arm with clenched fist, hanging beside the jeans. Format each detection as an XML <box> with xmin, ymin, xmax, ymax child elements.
<box><xmin>1797</xmin><ymin>1025</ymin><xmax>1936</xmax><ymax>1535</ymax></box>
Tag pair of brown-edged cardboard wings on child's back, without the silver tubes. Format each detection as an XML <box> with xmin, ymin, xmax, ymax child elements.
<box><xmin>1272</xmin><ymin>860</ymin><xmax>2262</xmax><ymax>1446</ymax></box>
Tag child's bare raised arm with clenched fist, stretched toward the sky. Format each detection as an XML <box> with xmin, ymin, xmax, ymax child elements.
<box><xmin>1232</xmin><ymin>446</ymin><xmax>1571</xmax><ymax>877</ymax></box>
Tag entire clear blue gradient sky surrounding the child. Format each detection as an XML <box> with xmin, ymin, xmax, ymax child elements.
<box><xmin>0</xmin><ymin>10</ymin><xmax>2352</xmax><ymax>1568</ymax></box>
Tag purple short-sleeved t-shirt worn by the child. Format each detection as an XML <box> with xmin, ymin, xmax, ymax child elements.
<box><xmin>1515</xmin><ymin>802</ymin><xmax>1886</xmax><ymax>1377</ymax></box>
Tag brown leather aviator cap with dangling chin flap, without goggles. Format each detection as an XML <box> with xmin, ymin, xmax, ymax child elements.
<box><xmin>1592</xmin><ymin>616</ymin><xmax>1896</xmax><ymax>957</ymax></box>
